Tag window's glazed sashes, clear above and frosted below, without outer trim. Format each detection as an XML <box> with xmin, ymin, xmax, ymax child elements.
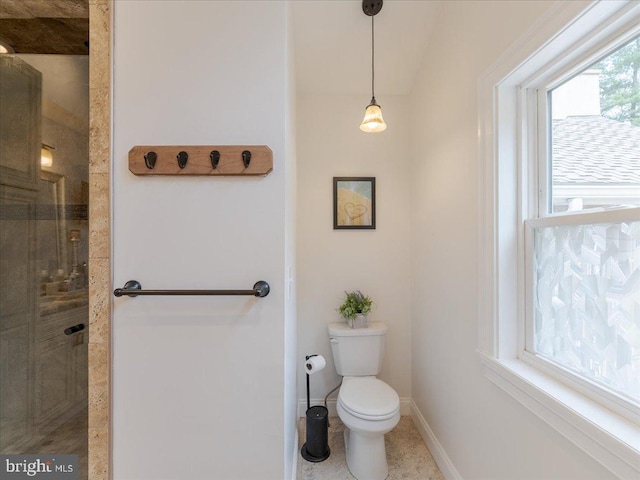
<box><xmin>522</xmin><ymin>34</ymin><xmax>640</xmax><ymax>419</ymax></box>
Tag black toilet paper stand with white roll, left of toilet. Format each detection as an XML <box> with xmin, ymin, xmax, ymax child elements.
<box><xmin>300</xmin><ymin>355</ymin><xmax>331</xmax><ymax>462</ymax></box>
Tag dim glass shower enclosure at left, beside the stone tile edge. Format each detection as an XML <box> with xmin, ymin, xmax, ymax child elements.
<box><xmin>0</xmin><ymin>54</ymin><xmax>89</xmax><ymax>479</ymax></box>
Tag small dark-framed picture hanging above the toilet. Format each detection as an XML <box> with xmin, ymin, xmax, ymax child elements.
<box><xmin>333</xmin><ymin>177</ymin><xmax>376</xmax><ymax>230</ymax></box>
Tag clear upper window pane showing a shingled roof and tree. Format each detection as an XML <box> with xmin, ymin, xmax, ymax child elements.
<box><xmin>549</xmin><ymin>37</ymin><xmax>640</xmax><ymax>213</ymax></box>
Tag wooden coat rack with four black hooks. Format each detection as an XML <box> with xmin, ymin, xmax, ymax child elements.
<box><xmin>129</xmin><ymin>145</ymin><xmax>273</xmax><ymax>176</ymax></box>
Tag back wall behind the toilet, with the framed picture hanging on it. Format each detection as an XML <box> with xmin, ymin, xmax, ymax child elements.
<box><xmin>296</xmin><ymin>92</ymin><xmax>413</xmax><ymax>415</ymax></box>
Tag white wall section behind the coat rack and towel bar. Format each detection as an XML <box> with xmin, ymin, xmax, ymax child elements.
<box><xmin>113</xmin><ymin>0</ymin><xmax>295</xmax><ymax>480</ymax></box>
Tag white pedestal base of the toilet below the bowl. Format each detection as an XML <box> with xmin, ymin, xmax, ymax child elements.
<box><xmin>344</xmin><ymin>427</ymin><xmax>389</xmax><ymax>480</ymax></box>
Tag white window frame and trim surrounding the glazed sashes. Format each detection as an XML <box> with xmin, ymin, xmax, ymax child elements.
<box><xmin>478</xmin><ymin>1</ymin><xmax>640</xmax><ymax>478</ymax></box>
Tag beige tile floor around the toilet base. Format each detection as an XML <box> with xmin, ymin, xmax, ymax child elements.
<box><xmin>297</xmin><ymin>417</ymin><xmax>444</xmax><ymax>480</ymax></box>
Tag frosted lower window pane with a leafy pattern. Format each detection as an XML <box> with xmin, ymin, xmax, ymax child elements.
<box><xmin>534</xmin><ymin>222</ymin><xmax>640</xmax><ymax>402</ymax></box>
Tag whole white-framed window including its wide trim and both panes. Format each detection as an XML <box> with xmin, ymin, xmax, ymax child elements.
<box><xmin>478</xmin><ymin>1</ymin><xmax>640</xmax><ymax>478</ymax></box>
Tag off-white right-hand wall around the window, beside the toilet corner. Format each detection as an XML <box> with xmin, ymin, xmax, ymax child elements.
<box><xmin>411</xmin><ymin>1</ymin><xmax>611</xmax><ymax>480</ymax></box>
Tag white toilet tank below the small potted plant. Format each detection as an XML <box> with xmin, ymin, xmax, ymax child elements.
<box><xmin>329</xmin><ymin>322</ymin><xmax>387</xmax><ymax>377</ymax></box>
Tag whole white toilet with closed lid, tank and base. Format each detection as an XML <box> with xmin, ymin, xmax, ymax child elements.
<box><xmin>329</xmin><ymin>322</ymin><xmax>400</xmax><ymax>480</ymax></box>
